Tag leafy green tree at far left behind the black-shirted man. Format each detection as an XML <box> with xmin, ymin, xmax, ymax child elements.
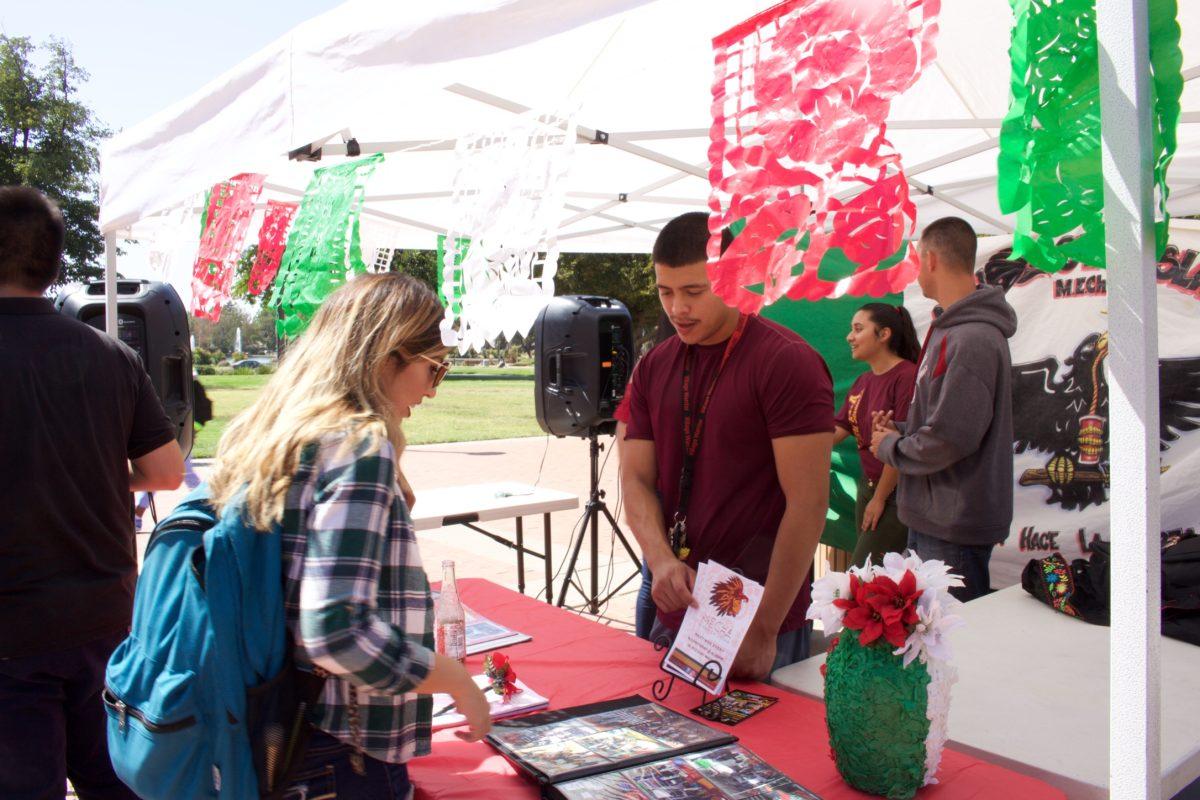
<box><xmin>0</xmin><ymin>35</ymin><xmax>109</xmax><ymax>283</ymax></box>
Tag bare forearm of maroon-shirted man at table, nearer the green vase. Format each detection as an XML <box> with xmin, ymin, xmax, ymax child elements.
<box><xmin>754</xmin><ymin>500</ymin><xmax>826</xmax><ymax>632</ymax></box>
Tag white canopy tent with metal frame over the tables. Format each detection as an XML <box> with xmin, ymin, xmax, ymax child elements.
<box><xmin>101</xmin><ymin>0</ymin><xmax>1200</xmax><ymax>798</ymax></box>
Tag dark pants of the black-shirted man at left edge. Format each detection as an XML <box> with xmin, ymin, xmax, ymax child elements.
<box><xmin>0</xmin><ymin>633</ymin><xmax>137</xmax><ymax>800</ymax></box>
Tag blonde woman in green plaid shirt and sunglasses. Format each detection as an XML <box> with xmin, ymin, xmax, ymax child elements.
<box><xmin>211</xmin><ymin>273</ymin><xmax>491</xmax><ymax>800</ymax></box>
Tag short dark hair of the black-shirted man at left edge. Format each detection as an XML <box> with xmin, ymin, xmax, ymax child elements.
<box><xmin>0</xmin><ymin>186</ymin><xmax>66</xmax><ymax>291</ymax></box>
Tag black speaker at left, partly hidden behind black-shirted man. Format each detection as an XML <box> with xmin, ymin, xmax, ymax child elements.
<box><xmin>54</xmin><ymin>281</ymin><xmax>193</xmax><ymax>456</ymax></box>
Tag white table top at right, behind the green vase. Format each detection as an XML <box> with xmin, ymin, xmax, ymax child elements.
<box><xmin>772</xmin><ymin>587</ymin><xmax>1200</xmax><ymax>798</ymax></box>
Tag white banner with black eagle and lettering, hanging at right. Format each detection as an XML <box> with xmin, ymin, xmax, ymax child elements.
<box><xmin>905</xmin><ymin>231</ymin><xmax>1200</xmax><ymax>589</ymax></box>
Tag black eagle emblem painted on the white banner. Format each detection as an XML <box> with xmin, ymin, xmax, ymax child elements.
<box><xmin>1013</xmin><ymin>333</ymin><xmax>1200</xmax><ymax>511</ymax></box>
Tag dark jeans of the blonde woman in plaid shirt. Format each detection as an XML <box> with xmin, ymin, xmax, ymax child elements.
<box><xmin>283</xmin><ymin>730</ymin><xmax>413</xmax><ymax>800</ymax></box>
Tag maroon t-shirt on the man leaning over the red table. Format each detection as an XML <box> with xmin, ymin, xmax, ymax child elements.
<box><xmin>625</xmin><ymin>317</ymin><xmax>833</xmax><ymax>633</ymax></box>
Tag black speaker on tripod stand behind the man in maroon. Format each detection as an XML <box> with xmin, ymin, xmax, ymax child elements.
<box><xmin>534</xmin><ymin>295</ymin><xmax>634</xmax><ymax>437</ymax></box>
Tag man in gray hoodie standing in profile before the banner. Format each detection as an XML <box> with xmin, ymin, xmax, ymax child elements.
<box><xmin>871</xmin><ymin>217</ymin><xmax>1016</xmax><ymax>600</ymax></box>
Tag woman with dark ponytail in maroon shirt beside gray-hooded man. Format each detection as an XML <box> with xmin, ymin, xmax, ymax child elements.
<box><xmin>834</xmin><ymin>302</ymin><xmax>920</xmax><ymax>565</ymax></box>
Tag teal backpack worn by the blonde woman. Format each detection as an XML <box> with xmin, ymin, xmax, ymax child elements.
<box><xmin>103</xmin><ymin>485</ymin><xmax>324</xmax><ymax>800</ymax></box>
